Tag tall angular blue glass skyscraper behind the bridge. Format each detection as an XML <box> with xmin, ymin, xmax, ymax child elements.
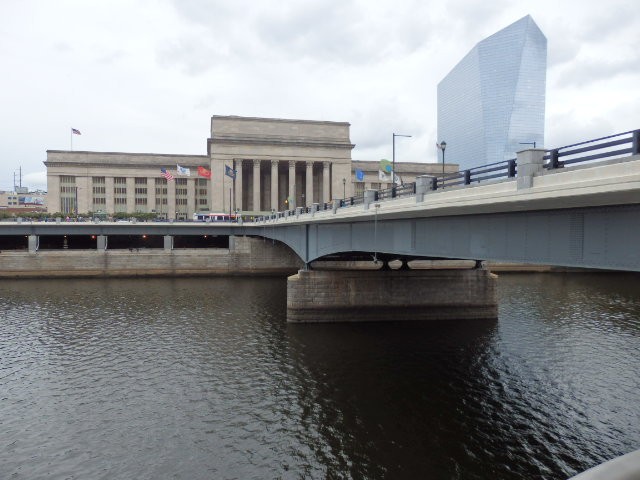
<box><xmin>438</xmin><ymin>15</ymin><xmax>547</xmax><ymax>170</ymax></box>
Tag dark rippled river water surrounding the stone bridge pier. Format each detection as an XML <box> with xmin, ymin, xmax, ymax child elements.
<box><xmin>0</xmin><ymin>273</ymin><xmax>640</xmax><ymax>480</ymax></box>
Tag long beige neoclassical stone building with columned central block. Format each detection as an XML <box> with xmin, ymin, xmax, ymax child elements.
<box><xmin>45</xmin><ymin>116</ymin><xmax>452</xmax><ymax>219</ymax></box>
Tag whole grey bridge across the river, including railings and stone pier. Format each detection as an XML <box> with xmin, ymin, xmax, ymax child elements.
<box><xmin>0</xmin><ymin>130</ymin><xmax>640</xmax><ymax>321</ymax></box>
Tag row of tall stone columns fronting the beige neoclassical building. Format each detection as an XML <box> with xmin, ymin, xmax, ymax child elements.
<box><xmin>233</xmin><ymin>159</ymin><xmax>331</xmax><ymax>211</ymax></box>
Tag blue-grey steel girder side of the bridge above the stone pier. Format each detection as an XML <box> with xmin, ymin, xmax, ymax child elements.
<box><xmin>260</xmin><ymin>205</ymin><xmax>640</xmax><ymax>271</ymax></box>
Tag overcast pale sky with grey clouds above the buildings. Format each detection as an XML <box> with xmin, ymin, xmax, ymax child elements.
<box><xmin>0</xmin><ymin>0</ymin><xmax>640</xmax><ymax>190</ymax></box>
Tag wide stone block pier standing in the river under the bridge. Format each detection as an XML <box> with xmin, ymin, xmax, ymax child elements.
<box><xmin>287</xmin><ymin>269</ymin><xmax>498</xmax><ymax>323</ymax></box>
